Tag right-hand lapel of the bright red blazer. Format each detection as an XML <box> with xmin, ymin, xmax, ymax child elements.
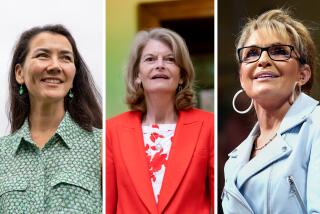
<box><xmin>158</xmin><ymin>111</ymin><xmax>203</xmax><ymax>213</ymax></box>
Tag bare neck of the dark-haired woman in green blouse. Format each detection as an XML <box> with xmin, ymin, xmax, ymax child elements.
<box><xmin>29</xmin><ymin>100</ymin><xmax>65</xmax><ymax>148</ymax></box>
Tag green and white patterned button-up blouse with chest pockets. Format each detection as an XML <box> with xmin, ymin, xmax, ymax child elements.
<box><xmin>0</xmin><ymin>113</ymin><xmax>102</xmax><ymax>214</ymax></box>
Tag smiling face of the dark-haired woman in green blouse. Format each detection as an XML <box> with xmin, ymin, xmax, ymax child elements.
<box><xmin>15</xmin><ymin>32</ymin><xmax>76</xmax><ymax>103</ymax></box>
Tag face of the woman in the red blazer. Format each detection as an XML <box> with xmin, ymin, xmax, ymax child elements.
<box><xmin>137</xmin><ymin>39</ymin><xmax>183</xmax><ymax>95</ymax></box>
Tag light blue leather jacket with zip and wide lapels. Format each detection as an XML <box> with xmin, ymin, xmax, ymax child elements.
<box><xmin>221</xmin><ymin>93</ymin><xmax>320</xmax><ymax>214</ymax></box>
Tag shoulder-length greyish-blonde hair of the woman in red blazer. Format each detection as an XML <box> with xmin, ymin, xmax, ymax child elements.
<box><xmin>125</xmin><ymin>28</ymin><xmax>194</xmax><ymax>113</ymax></box>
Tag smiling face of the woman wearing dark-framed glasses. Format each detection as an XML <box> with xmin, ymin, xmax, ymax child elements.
<box><xmin>240</xmin><ymin>30</ymin><xmax>310</xmax><ymax>106</ymax></box>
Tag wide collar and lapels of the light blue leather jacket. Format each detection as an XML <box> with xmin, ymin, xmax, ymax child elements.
<box><xmin>229</xmin><ymin>93</ymin><xmax>319</xmax><ymax>188</ymax></box>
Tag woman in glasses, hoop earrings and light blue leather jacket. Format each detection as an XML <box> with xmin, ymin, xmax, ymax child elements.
<box><xmin>222</xmin><ymin>9</ymin><xmax>320</xmax><ymax>214</ymax></box>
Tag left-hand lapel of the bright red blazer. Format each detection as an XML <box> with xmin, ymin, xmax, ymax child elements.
<box><xmin>118</xmin><ymin>112</ymin><xmax>157</xmax><ymax>213</ymax></box>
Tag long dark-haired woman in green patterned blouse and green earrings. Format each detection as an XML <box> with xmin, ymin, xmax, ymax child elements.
<box><xmin>0</xmin><ymin>25</ymin><xmax>102</xmax><ymax>213</ymax></box>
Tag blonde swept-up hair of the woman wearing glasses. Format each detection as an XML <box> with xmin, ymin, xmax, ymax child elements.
<box><xmin>236</xmin><ymin>9</ymin><xmax>317</xmax><ymax>93</ymax></box>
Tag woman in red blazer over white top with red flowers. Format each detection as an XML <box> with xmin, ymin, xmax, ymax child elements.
<box><xmin>106</xmin><ymin>28</ymin><xmax>214</xmax><ymax>214</ymax></box>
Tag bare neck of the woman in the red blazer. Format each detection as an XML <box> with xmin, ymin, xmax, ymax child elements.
<box><xmin>142</xmin><ymin>92</ymin><xmax>178</xmax><ymax>125</ymax></box>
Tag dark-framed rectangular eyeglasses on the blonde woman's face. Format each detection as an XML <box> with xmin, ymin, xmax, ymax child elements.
<box><xmin>237</xmin><ymin>45</ymin><xmax>305</xmax><ymax>64</ymax></box>
